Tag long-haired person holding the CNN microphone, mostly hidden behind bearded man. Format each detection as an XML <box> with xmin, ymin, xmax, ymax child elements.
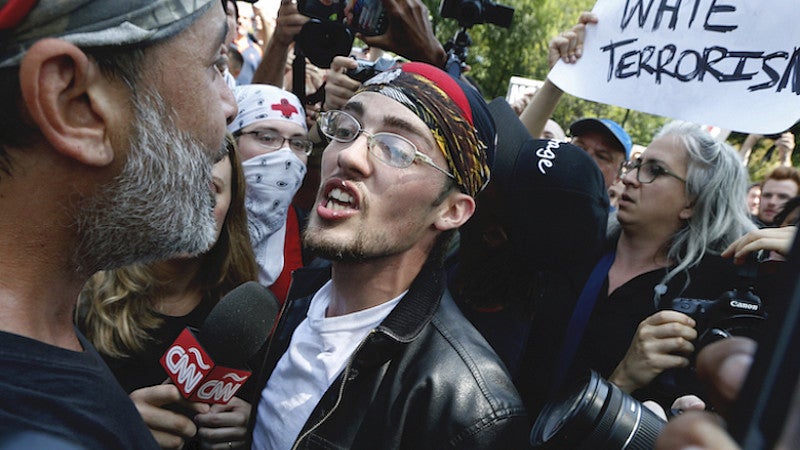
<box><xmin>77</xmin><ymin>137</ymin><xmax>256</xmax><ymax>448</ymax></box>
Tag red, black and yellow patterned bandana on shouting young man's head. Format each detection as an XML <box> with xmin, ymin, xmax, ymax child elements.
<box><xmin>359</xmin><ymin>62</ymin><xmax>495</xmax><ymax>197</ymax></box>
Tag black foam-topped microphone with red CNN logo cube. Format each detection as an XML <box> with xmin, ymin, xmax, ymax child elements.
<box><xmin>160</xmin><ymin>281</ymin><xmax>280</xmax><ymax>404</ymax></box>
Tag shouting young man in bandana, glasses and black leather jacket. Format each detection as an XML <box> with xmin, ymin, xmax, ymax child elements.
<box><xmin>247</xmin><ymin>63</ymin><xmax>529</xmax><ymax>449</ymax></box>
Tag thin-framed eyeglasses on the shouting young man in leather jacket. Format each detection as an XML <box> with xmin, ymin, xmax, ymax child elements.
<box><xmin>317</xmin><ymin>110</ymin><xmax>455</xmax><ymax>179</ymax></box>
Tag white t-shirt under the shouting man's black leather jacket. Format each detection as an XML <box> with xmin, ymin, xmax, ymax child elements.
<box><xmin>252</xmin><ymin>281</ymin><xmax>405</xmax><ymax>450</ymax></box>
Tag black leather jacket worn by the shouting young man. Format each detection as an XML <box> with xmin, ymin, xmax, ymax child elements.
<box><xmin>251</xmin><ymin>267</ymin><xmax>530</xmax><ymax>449</ymax></box>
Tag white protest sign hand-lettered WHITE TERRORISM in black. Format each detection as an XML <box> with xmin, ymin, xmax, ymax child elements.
<box><xmin>549</xmin><ymin>0</ymin><xmax>800</xmax><ymax>134</ymax></box>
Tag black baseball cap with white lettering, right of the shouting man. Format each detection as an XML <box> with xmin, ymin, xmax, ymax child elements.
<box><xmin>489</xmin><ymin>97</ymin><xmax>609</xmax><ymax>267</ymax></box>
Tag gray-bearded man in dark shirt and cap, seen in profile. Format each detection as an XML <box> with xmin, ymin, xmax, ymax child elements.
<box><xmin>0</xmin><ymin>0</ymin><xmax>236</xmax><ymax>449</ymax></box>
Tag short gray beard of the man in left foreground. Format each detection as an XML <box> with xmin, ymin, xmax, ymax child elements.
<box><xmin>74</xmin><ymin>88</ymin><xmax>225</xmax><ymax>273</ymax></box>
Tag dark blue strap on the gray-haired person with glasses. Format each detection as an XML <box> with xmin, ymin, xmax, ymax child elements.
<box><xmin>551</xmin><ymin>251</ymin><xmax>616</xmax><ymax>394</ymax></box>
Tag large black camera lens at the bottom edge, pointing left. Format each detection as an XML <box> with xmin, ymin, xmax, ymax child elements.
<box><xmin>531</xmin><ymin>371</ymin><xmax>666</xmax><ymax>450</ymax></box>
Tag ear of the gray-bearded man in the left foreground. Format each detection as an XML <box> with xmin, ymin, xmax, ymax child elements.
<box><xmin>20</xmin><ymin>38</ymin><xmax>121</xmax><ymax>166</ymax></box>
